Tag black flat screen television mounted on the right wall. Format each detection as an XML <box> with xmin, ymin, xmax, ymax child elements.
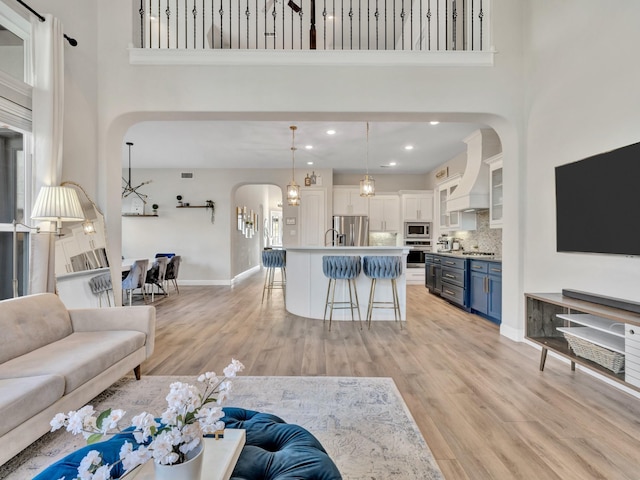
<box><xmin>555</xmin><ymin>143</ymin><xmax>640</xmax><ymax>255</ymax></box>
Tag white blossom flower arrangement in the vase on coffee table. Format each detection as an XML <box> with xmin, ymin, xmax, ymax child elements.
<box><xmin>50</xmin><ymin>359</ymin><xmax>244</xmax><ymax>480</ymax></box>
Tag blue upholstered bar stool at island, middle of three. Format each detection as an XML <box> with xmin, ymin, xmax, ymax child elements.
<box><xmin>322</xmin><ymin>255</ymin><xmax>362</xmax><ymax>330</ymax></box>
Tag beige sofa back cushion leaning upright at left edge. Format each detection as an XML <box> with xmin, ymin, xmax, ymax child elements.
<box><xmin>0</xmin><ymin>293</ymin><xmax>72</xmax><ymax>363</ymax></box>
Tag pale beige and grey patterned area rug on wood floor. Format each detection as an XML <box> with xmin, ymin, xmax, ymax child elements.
<box><xmin>0</xmin><ymin>376</ymin><xmax>444</xmax><ymax>480</ymax></box>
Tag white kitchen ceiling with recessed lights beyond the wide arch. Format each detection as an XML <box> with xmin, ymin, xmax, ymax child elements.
<box><xmin>122</xmin><ymin>121</ymin><xmax>486</xmax><ymax>174</ymax></box>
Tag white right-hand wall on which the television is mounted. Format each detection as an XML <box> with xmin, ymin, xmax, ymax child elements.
<box><xmin>523</xmin><ymin>0</ymin><xmax>640</xmax><ymax>301</ymax></box>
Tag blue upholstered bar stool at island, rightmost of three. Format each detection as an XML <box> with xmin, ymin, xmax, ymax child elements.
<box><xmin>362</xmin><ymin>255</ymin><xmax>402</xmax><ymax>329</ymax></box>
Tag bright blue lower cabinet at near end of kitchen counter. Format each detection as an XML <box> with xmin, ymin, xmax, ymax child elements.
<box><xmin>469</xmin><ymin>260</ymin><xmax>502</xmax><ymax>325</ymax></box>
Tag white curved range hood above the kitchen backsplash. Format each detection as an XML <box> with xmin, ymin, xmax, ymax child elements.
<box><xmin>447</xmin><ymin>128</ymin><xmax>502</xmax><ymax>212</ymax></box>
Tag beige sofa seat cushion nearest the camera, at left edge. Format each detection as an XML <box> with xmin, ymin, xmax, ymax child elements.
<box><xmin>0</xmin><ymin>375</ymin><xmax>64</xmax><ymax>435</ymax></box>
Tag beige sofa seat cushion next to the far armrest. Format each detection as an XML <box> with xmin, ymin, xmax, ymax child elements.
<box><xmin>0</xmin><ymin>330</ymin><xmax>146</xmax><ymax>395</ymax></box>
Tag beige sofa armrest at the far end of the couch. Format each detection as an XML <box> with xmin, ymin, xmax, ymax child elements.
<box><xmin>69</xmin><ymin>305</ymin><xmax>156</xmax><ymax>358</ymax></box>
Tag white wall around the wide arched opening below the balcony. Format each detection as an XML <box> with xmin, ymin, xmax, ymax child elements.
<box><xmin>22</xmin><ymin>0</ymin><xmax>524</xmax><ymax>320</ymax></box>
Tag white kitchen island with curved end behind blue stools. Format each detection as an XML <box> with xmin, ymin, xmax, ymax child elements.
<box><xmin>286</xmin><ymin>246</ymin><xmax>409</xmax><ymax>321</ymax></box>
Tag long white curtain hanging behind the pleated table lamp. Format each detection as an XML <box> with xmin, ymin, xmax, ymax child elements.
<box><xmin>29</xmin><ymin>15</ymin><xmax>64</xmax><ymax>293</ymax></box>
